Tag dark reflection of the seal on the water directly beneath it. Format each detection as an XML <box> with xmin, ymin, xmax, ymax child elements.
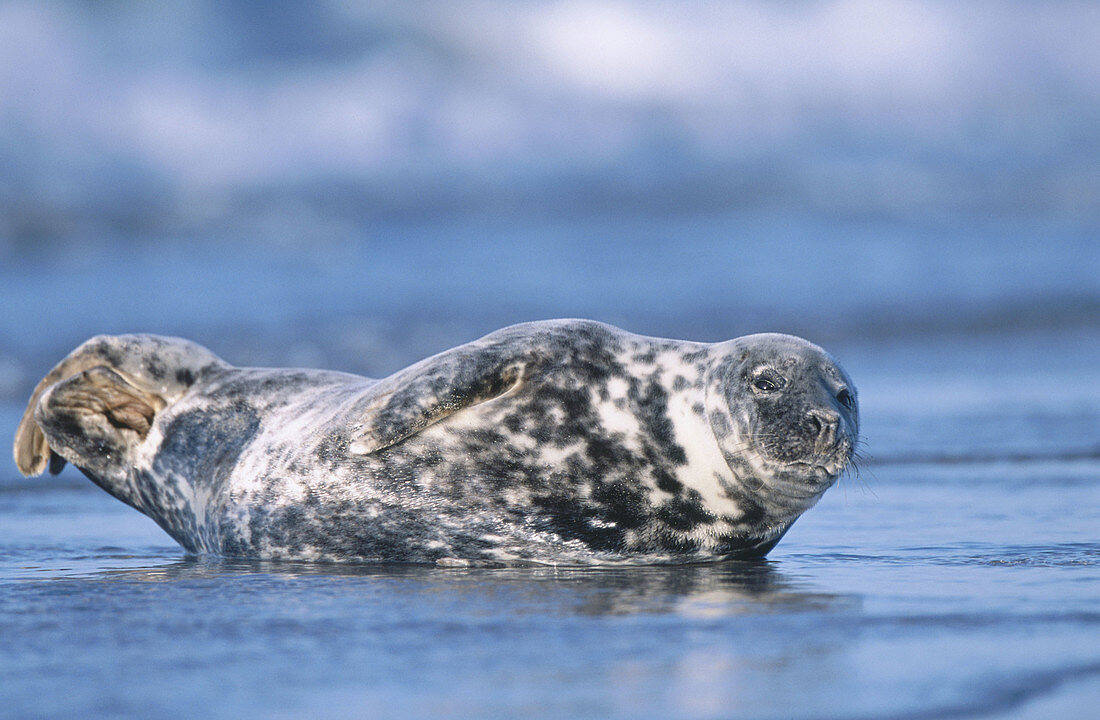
<box><xmin>70</xmin><ymin>557</ymin><xmax>857</xmax><ymax>617</ymax></box>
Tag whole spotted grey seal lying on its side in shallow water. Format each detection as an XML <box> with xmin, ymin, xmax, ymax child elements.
<box><xmin>14</xmin><ymin>320</ymin><xmax>859</xmax><ymax>564</ymax></box>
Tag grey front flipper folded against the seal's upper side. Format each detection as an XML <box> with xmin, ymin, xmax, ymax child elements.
<box><xmin>349</xmin><ymin>326</ymin><xmax>548</xmax><ymax>455</ymax></box>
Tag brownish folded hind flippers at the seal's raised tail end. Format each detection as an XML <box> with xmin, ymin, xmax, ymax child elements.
<box><xmin>14</xmin><ymin>365</ymin><xmax>166</xmax><ymax>475</ymax></box>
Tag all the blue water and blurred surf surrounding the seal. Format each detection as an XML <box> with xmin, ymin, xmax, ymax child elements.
<box><xmin>0</xmin><ymin>0</ymin><xmax>1100</xmax><ymax>719</ymax></box>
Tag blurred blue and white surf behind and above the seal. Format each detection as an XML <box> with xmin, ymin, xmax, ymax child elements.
<box><xmin>0</xmin><ymin>0</ymin><xmax>1100</xmax><ymax>405</ymax></box>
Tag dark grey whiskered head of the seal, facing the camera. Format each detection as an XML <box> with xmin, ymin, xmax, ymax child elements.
<box><xmin>707</xmin><ymin>333</ymin><xmax>859</xmax><ymax>512</ymax></box>
